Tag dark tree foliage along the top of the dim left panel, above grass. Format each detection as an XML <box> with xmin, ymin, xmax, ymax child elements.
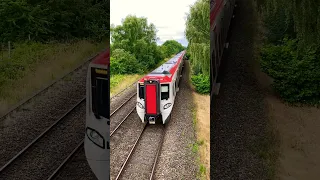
<box><xmin>0</xmin><ymin>0</ymin><xmax>110</xmax><ymax>43</ymax></box>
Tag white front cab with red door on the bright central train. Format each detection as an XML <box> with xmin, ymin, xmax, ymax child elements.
<box><xmin>137</xmin><ymin>80</ymin><xmax>176</xmax><ymax>124</ymax></box>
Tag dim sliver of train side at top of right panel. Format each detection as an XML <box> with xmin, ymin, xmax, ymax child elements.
<box><xmin>210</xmin><ymin>0</ymin><xmax>236</xmax><ymax>97</ymax></box>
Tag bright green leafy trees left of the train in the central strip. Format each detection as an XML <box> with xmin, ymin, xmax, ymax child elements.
<box><xmin>110</xmin><ymin>15</ymin><xmax>184</xmax><ymax>74</ymax></box>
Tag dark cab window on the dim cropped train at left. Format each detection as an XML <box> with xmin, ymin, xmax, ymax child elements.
<box><xmin>91</xmin><ymin>68</ymin><xmax>110</xmax><ymax>119</ymax></box>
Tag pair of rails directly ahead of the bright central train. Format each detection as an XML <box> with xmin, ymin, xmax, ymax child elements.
<box><xmin>115</xmin><ymin>123</ymin><xmax>165</xmax><ymax>180</ymax></box>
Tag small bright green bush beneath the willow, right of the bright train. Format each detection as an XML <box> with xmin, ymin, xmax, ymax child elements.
<box><xmin>191</xmin><ymin>74</ymin><xmax>210</xmax><ymax>94</ymax></box>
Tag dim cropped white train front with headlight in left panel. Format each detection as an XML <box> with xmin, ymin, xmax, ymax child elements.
<box><xmin>84</xmin><ymin>49</ymin><xmax>110</xmax><ymax>180</ymax></box>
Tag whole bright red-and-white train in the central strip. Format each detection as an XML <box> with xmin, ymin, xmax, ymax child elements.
<box><xmin>136</xmin><ymin>51</ymin><xmax>186</xmax><ymax>124</ymax></box>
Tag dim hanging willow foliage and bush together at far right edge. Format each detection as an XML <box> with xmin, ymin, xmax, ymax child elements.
<box><xmin>256</xmin><ymin>0</ymin><xmax>320</xmax><ymax>104</ymax></box>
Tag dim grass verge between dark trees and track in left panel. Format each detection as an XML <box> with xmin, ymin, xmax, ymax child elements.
<box><xmin>0</xmin><ymin>40</ymin><xmax>105</xmax><ymax>115</ymax></box>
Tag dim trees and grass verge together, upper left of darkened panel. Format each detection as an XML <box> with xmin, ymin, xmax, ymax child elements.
<box><xmin>0</xmin><ymin>0</ymin><xmax>110</xmax><ymax>113</ymax></box>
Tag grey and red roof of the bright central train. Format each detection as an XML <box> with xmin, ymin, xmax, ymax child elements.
<box><xmin>139</xmin><ymin>51</ymin><xmax>185</xmax><ymax>83</ymax></box>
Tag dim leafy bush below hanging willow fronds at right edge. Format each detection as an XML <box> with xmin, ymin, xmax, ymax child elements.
<box><xmin>261</xmin><ymin>39</ymin><xmax>320</xmax><ymax>104</ymax></box>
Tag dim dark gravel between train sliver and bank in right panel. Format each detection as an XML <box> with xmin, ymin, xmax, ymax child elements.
<box><xmin>210</xmin><ymin>0</ymin><xmax>268</xmax><ymax>180</ymax></box>
